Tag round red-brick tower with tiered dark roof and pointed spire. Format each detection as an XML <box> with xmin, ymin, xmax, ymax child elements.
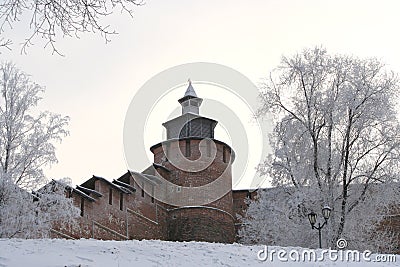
<box><xmin>150</xmin><ymin>80</ymin><xmax>235</xmax><ymax>243</ymax></box>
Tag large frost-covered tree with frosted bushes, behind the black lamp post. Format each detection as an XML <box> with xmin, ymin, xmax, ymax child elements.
<box><xmin>241</xmin><ymin>48</ymin><xmax>400</xmax><ymax>253</ymax></box>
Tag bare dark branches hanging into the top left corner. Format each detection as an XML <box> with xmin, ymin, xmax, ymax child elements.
<box><xmin>0</xmin><ymin>0</ymin><xmax>143</xmax><ymax>54</ymax></box>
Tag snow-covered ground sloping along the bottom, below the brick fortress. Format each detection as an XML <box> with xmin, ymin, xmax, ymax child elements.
<box><xmin>0</xmin><ymin>239</ymin><xmax>400</xmax><ymax>267</ymax></box>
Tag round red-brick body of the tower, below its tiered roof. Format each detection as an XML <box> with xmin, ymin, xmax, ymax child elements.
<box><xmin>151</xmin><ymin>138</ymin><xmax>235</xmax><ymax>243</ymax></box>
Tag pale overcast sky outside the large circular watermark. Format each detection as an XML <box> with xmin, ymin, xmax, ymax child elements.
<box><xmin>1</xmin><ymin>0</ymin><xmax>400</xmax><ymax>188</ymax></box>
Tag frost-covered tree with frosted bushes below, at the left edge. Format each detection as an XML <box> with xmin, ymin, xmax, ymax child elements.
<box><xmin>0</xmin><ymin>63</ymin><xmax>78</xmax><ymax>238</ymax></box>
